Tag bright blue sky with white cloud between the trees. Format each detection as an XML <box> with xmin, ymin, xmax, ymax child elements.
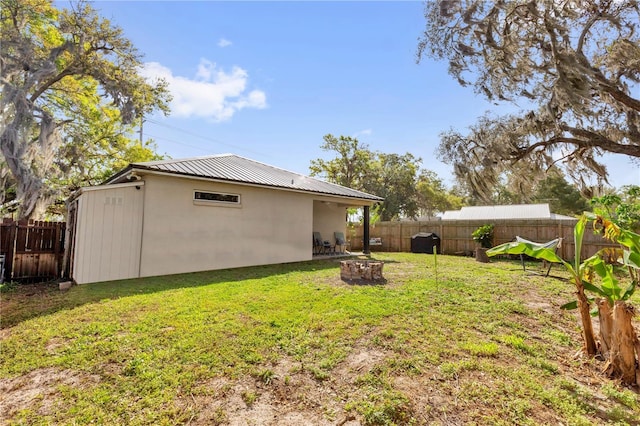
<box><xmin>93</xmin><ymin>1</ymin><xmax>640</xmax><ymax>190</ymax></box>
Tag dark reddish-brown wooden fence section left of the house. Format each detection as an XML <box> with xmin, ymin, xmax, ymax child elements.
<box><xmin>0</xmin><ymin>218</ymin><xmax>66</xmax><ymax>282</ymax></box>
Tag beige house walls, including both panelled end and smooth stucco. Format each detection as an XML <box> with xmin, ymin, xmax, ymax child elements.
<box><xmin>72</xmin><ymin>174</ymin><xmax>362</xmax><ymax>284</ymax></box>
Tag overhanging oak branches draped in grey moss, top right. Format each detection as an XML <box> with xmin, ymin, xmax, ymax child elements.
<box><xmin>418</xmin><ymin>0</ymin><xmax>640</xmax><ymax>195</ymax></box>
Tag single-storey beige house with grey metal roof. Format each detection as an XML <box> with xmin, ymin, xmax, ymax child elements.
<box><xmin>68</xmin><ymin>154</ymin><xmax>382</xmax><ymax>284</ymax></box>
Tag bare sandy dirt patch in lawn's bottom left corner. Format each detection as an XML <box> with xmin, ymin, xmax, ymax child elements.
<box><xmin>0</xmin><ymin>368</ymin><xmax>100</xmax><ymax>424</ymax></box>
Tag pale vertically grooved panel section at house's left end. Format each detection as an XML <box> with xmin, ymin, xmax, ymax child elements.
<box><xmin>73</xmin><ymin>184</ymin><xmax>144</xmax><ymax>284</ymax></box>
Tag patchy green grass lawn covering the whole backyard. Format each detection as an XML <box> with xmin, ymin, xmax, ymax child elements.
<box><xmin>0</xmin><ymin>253</ymin><xmax>640</xmax><ymax>426</ymax></box>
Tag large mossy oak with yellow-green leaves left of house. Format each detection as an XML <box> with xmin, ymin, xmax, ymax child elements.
<box><xmin>0</xmin><ymin>0</ymin><xmax>168</xmax><ymax>218</ymax></box>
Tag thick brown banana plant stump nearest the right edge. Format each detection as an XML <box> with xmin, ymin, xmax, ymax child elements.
<box><xmin>610</xmin><ymin>300</ymin><xmax>639</xmax><ymax>385</ymax></box>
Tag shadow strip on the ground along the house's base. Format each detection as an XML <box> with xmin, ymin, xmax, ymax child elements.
<box><xmin>0</xmin><ymin>259</ymin><xmax>356</xmax><ymax>329</ymax></box>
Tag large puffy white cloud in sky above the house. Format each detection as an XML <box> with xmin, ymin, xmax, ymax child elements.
<box><xmin>141</xmin><ymin>59</ymin><xmax>267</xmax><ymax>121</ymax></box>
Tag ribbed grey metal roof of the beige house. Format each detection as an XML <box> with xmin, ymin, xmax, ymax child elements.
<box><xmin>105</xmin><ymin>154</ymin><xmax>384</xmax><ymax>201</ymax></box>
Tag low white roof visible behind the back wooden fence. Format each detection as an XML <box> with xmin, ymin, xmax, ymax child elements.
<box><xmin>442</xmin><ymin>204</ymin><xmax>574</xmax><ymax>220</ymax></box>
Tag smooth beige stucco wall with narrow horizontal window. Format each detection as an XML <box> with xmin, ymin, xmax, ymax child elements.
<box><xmin>140</xmin><ymin>175</ymin><xmax>318</xmax><ymax>276</ymax></box>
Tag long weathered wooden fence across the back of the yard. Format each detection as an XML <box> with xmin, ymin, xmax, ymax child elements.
<box><xmin>347</xmin><ymin>219</ymin><xmax>617</xmax><ymax>260</ymax></box>
